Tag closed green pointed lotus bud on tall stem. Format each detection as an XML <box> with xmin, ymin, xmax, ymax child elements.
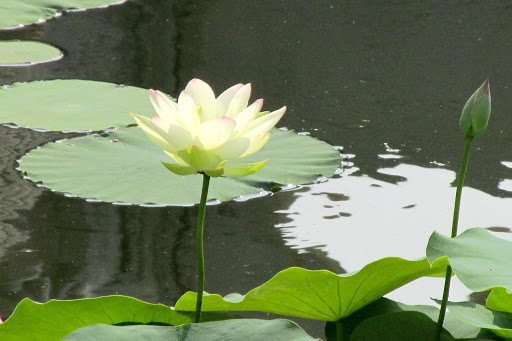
<box><xmin>459</xmin><ymin>79</ymin><xmax>491</xmax><ymax>137</ymax></box>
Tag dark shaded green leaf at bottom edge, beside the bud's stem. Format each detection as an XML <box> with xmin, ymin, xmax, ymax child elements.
<box><xmin>350</xmin><ymin>311</ymin><xmax>455</xmax><ymax>341</ymax></box>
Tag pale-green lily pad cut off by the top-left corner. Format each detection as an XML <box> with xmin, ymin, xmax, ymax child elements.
<box><xmin>0</xmin><ymin>0</ymin><xmax>125</xmax><ymax>29</ymax></box>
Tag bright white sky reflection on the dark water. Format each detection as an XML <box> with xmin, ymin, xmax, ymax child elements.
<box><xmin>276</xmin><ymin>163</ymin><xmax>512</xmax><ymax>304</ymax></box>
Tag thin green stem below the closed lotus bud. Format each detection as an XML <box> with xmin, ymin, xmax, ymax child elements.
<box><xmin>436</xmin><ymin>135</ymin><xmax>473</xmax><ymax>341</ymax></box>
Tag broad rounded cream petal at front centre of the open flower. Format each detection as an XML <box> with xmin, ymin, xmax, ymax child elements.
<box><xmin>197</xmin><ymin>116</ymin><xmax>236</xmax><ymax>150</ymax></box>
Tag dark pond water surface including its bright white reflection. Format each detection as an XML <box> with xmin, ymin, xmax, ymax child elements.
<box><xmin>0</xmin><ymin>0</ymin><xmax>512</xmax><ymax>336</ymax></box>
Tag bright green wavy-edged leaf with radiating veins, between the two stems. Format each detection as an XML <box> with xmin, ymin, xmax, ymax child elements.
<box><xmin>176</xmin><ymin>257</ymin><xmax>446</xmax><ymax>321</ymax></box>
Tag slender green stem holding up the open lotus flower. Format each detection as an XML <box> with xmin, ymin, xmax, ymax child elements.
<box><xmin>195</xmin><ymin>174</ymin><xmax>210</xmax><ymax>323</ymax></box>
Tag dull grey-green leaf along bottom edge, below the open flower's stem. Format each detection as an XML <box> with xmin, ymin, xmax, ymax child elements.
<box><xmin>64</xmin><ymin>319</ymin><xmax>318</xmax><ymax>341</ymax></box>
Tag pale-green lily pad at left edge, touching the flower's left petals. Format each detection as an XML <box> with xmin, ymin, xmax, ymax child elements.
<box><xmin>0</xmin><ymin>79</ymin><xmax>154</xmax><ymax>131</ymax></box>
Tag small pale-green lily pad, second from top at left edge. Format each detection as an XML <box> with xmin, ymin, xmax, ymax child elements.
<box><xmin>0</xmin><ymin>40</ymin><xmax>62</xmax><ymax>66</ymax></box>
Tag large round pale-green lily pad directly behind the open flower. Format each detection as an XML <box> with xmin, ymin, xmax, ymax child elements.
<box><xmin>20</xmin><ymin>127</ymin><xmax>340</xmax><ymax>205</ymax></box>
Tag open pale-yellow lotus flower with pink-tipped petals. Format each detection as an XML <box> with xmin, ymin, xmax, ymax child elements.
<box><xmin>131</xmin><ymin>79</ymin><xmax>286</xmax><ymax>177</ymax></box>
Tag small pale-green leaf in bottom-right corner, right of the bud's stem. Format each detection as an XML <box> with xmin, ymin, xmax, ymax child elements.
<box><xmin>448</xmin><ymin>302</ymin><xmax>512</xmax><ymax>339</ymax></box>
